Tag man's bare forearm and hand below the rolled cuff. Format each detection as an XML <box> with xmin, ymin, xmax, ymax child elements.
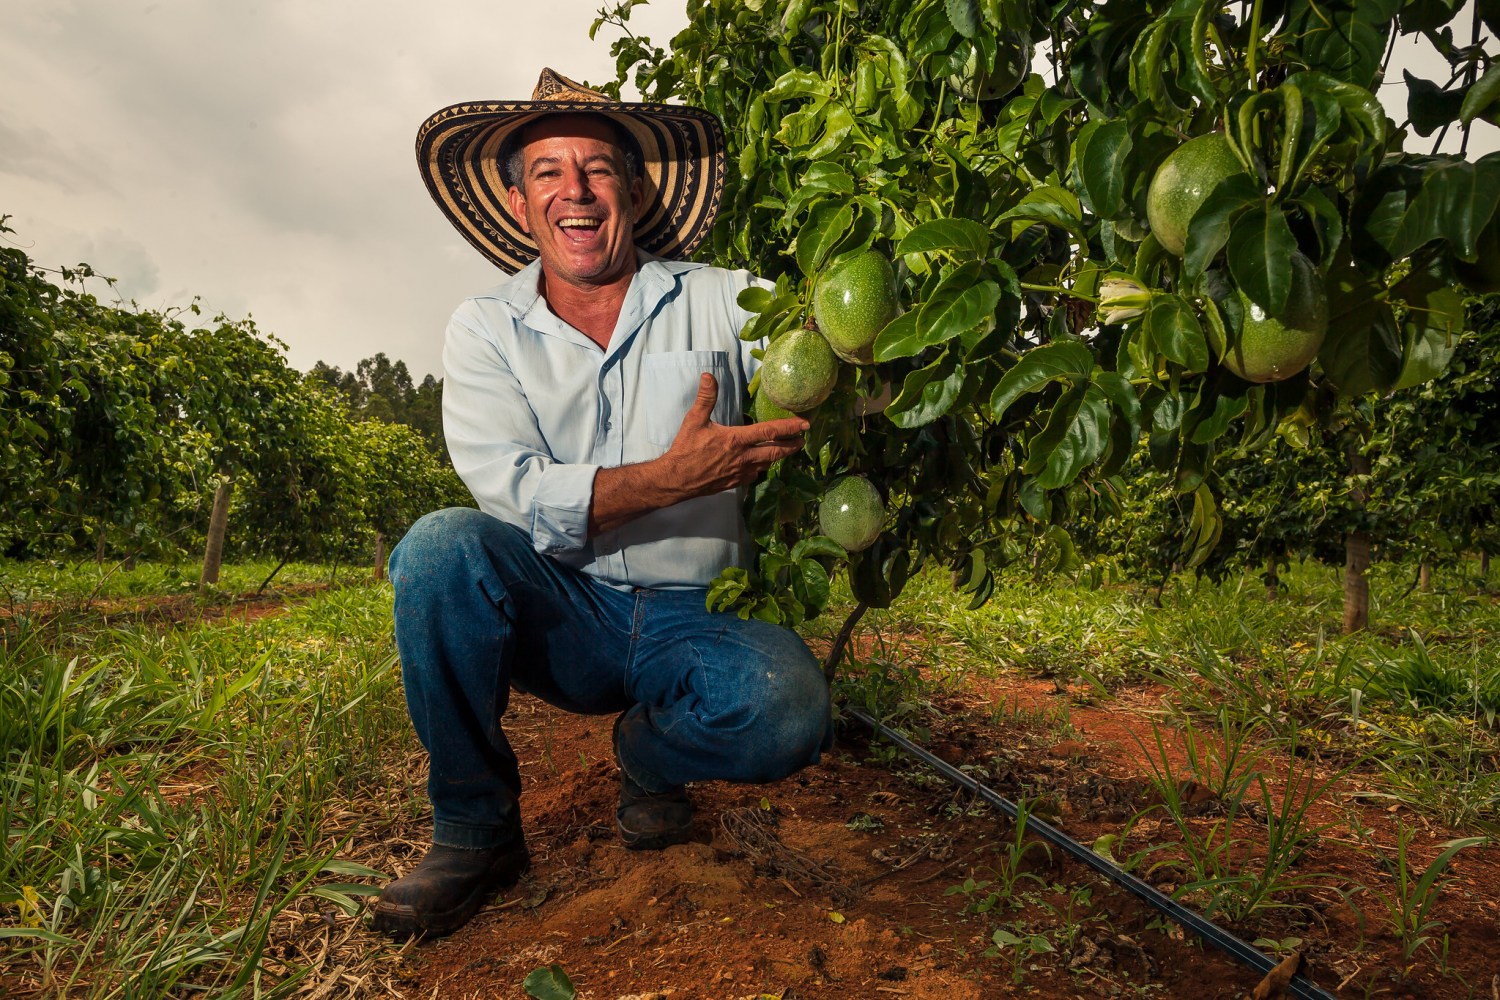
<box><xmin>588</xmin><ymin>372</ymin><xmax>809</xmax><ymax>535</ymax></box>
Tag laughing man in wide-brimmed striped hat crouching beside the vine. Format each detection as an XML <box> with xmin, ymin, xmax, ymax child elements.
<box><xmin>375</xmin><ymin>70</ymin><xmax>830</xmax><ymax>936</ymax></box>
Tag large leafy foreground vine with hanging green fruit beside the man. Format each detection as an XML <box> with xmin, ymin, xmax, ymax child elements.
<box><xmin>596</xmin><ymin>0</ymin><xmax>1500</xmax><ymax>628</ymax></box>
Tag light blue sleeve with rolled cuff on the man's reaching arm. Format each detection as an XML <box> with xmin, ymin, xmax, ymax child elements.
<box><xmin>443</xmin><ymin>309</ymin><xmax>599</xmax><ymax>555</ymax></box>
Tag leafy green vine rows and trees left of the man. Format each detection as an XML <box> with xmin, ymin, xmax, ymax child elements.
<box><xmin>0</xmin><ymin>217</ymin><xmax>473</xmax><ymax>569</ymax></box>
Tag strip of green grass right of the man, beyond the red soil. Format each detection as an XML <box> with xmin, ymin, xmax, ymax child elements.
<box><xmin>809</xmin><ymin>562</ymin><xmax>1500</xmax><ymax>832</ymax></box>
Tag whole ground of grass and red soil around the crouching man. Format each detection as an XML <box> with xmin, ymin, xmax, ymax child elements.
<box><xmin>0</xmin><ymin>551</ymin><xmax>1500</xmax><ymax>999</ymax></box>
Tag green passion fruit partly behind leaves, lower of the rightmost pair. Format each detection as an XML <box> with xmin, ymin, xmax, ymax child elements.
<box><xmin>1221</xmin><ymin>253</ymin><xmax>1328</xmax><ymax>382</ymax></box>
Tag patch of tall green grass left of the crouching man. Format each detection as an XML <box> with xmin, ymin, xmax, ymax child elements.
<box><xmin>0</xmin><ymin>567</ymin><xmax>411</xmax><ymax>997</ymax></box>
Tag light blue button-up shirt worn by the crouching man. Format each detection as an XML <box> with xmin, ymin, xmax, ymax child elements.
<box><xmin>443</xmin><ymin>253</ymin><xmax>762</xmax><ymax>589</ymax></box>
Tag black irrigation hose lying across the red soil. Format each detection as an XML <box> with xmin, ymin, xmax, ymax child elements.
<box><xmin>843</xmin><ymin>705</ymin><xmax>1337</xmax><ymax>1000</ymax></box>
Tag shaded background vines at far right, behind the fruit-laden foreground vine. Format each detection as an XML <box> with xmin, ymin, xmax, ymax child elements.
<box><xmin>1077</xmin><ymin>295</ymin><xmax>1500</xmax><ymax>630</ymax></box>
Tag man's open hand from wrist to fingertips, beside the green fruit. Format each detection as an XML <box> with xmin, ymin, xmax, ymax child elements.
<box><xmin>662</xmin><ymin>372</ymin><xmax>807</xmax><ymax>499</ymax></box>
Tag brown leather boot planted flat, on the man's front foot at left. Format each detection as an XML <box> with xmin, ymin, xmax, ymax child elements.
<box><xmin>371</xmin><ymin>840</ymin><xmax>531</xmax><ymax>937</ymax></box>
